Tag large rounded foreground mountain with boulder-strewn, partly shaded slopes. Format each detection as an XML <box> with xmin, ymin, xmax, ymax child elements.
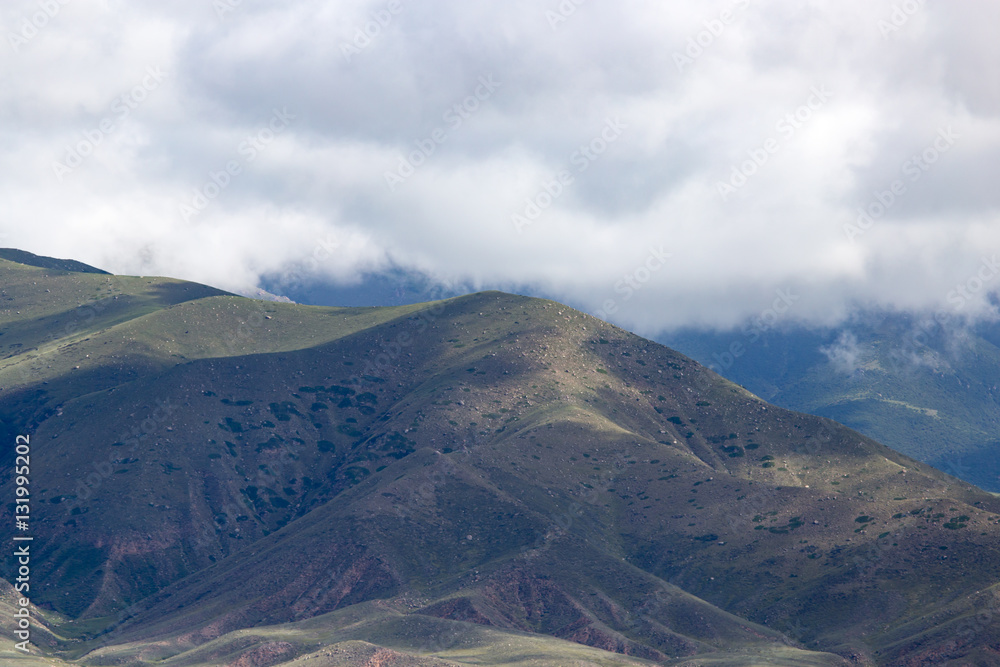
<box><xmin>0</xmin><ymin>253</ymin><xmax>1000</xmax><ymax>666</ymax></box>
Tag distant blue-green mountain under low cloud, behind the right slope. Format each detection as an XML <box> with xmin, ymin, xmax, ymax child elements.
<box><xmin>660</xmin><ymin>312</ymin><xmax>1000</xmax><ymax>492</ymax></box>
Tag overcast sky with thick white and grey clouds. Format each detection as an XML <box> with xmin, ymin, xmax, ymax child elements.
<box><xmin>0</xmin><ymin>0</ymin><xmax>1000</xmax><ymax>335</ymax></box>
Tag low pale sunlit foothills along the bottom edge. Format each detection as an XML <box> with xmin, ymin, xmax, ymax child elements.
<box><xmin>76</xmin><ymin>600</ymin><xmax>847</xmax><ymax>667</ymax></box>
